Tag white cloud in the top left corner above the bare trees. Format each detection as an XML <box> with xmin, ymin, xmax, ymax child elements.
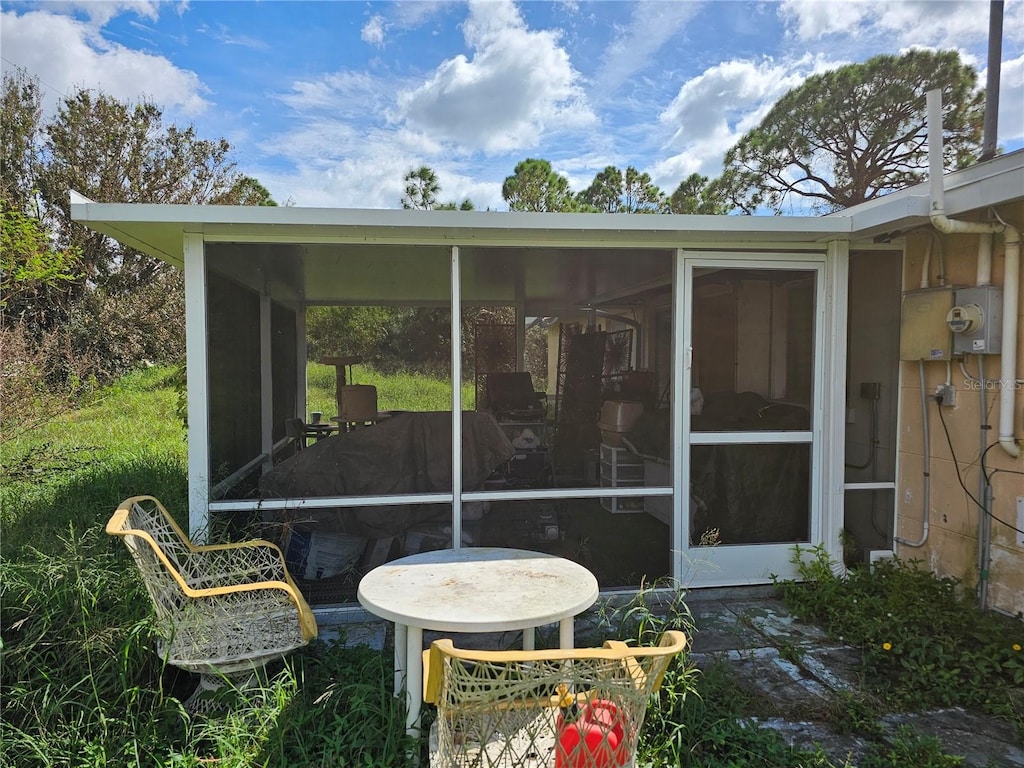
<box><xmin>0</xmin><ymin>10</ymin><xmax>208</xmax><ymax>116</ymax></box>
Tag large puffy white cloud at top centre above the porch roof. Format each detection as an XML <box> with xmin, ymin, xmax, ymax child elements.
<box><xmin>398</xmin><ymin>2</ymin><xmax>595</xmax><ymax>153</ymax></box>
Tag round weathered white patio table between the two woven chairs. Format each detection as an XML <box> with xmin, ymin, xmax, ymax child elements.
<box><xmin>358</xmin><ymin>547</ymin><xmax>598</xmax><ymax>735</ymax></box>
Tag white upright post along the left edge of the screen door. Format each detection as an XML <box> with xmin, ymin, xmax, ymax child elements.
<box><xmin>669</xmin><ymin>248</ymin><xmax>693</xmax><ymax>581</ymax></box>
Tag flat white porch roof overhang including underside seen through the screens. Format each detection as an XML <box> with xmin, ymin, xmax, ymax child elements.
<box><xmin>72</xmin><ymin>193</ymin><xmax>851</xmax><ymax>314</ymax></box>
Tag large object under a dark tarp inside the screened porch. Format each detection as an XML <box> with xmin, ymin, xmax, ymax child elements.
<box><xmin>260</xmin><ymin>411</ymin><xmax>515</xmax><ymax>537</ymax></box>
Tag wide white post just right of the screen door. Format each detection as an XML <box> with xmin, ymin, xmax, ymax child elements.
<box><xmin>823</xmin><ymin>241</ymin><xmax>850</xmax><ymax>563</ymax></box>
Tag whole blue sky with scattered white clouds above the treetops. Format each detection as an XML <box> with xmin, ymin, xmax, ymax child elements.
<box><xmin>0</xmin><ymin>0</ymin><xmax>1024</xmax><ymax>210</ymax></box>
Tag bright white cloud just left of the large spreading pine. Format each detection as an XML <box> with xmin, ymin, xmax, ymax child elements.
<box><xmin>651</xmin><ymin>55</ymin><xmax>840</xmax><ymax>183</ymax></box>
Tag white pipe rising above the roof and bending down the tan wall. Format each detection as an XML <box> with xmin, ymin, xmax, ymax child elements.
<box><xmin>927</xmin><ymin>89</ymin><xmax>1021</xmax><ymax>459</ymax></box>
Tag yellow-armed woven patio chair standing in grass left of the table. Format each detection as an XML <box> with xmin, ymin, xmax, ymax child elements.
<box><xmin>106</xmin><ymin>496</ymin><xmax>316</xmax><ymax>710</ymax></box>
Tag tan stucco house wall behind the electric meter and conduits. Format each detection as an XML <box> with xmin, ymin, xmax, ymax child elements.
<box><xmin>896</xmin><ymin>201</ymin><xmax>1024</xmax><ymax>614</ymax></box>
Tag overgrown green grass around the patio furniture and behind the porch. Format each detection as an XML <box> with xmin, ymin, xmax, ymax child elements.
<box><xmin>0</xmin><ymin>365</ymin><xmax>1007</xmax><ymax>768</ymax></box>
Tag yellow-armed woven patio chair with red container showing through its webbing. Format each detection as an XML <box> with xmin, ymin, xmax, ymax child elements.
<box><xmin>423</xmin><ymin>630</ymin><xmax>686</xmax><ymax>768</ymax></box>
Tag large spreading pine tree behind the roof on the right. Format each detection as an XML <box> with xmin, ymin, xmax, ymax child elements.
<box><xmin>723</xmin><ymin>50</ymin><xmax>983</xmax><ymax>213</ymax></box>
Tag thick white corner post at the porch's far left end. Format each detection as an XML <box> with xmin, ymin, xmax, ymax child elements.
<box><xmin>182</xmin><ymin>232</ymin><xmax>210</xmax><ymax>543</ymax></box>
